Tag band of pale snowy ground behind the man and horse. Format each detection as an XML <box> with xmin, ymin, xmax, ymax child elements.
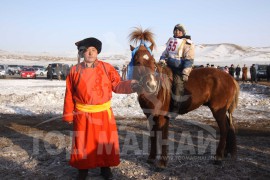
<box><xmin>0</xmin><ymin>79</ymin><xmax>270</xmax><ymax>122</ymax></box>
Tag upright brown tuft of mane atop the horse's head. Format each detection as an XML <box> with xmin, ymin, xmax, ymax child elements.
<box><xmin>129</xmin><ymin>27</ymin><xmax>156</xmax><ymax>47</ymax></box>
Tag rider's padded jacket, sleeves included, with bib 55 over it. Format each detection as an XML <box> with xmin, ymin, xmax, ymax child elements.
<box><xmin>160</xmin><ymin>37</ymin><xmax>194</xmax><ymax>60</ymax></box>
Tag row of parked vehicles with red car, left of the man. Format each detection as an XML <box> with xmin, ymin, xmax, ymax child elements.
<box><xmin>0</xmin><ymin>63</ymin><xmax>69</xmax><ymax>79</ymax></box>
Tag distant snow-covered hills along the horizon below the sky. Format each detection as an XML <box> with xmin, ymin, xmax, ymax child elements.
<box><xmin>0</xmin><ymin>43</ymin><xmax>270</xmax><ymax>65</ymax></box>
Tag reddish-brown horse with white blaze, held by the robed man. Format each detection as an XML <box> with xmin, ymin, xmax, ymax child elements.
<box><xmin>129</xmin><ymin>28</ymin><xmax>239</xmax><ymax>167</ymax></box>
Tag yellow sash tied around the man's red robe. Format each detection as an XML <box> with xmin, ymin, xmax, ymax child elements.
<box><xmin>76</xmin><ymin>101</ymin><xmax>112</xmax><ymax>119</ymax></box>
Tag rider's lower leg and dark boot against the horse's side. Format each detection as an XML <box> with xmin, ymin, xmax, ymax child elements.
<box><xmin>168</xmin><ymin>74</ymin><xmax>184</xmax><ymax>120</ymax></box>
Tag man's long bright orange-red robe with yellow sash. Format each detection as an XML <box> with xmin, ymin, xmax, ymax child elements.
<box><xmin>63</xmin><ymin>60</ymin><xmax>132</xmax><ymax>169</ymax></box>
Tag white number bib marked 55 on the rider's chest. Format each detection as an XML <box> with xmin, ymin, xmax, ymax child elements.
<box><xmin>166</xmin><ymin>37</ymin><xmax>185</xmax><ymax>59</ymax></box>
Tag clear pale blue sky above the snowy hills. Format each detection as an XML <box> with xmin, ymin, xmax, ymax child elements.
<box><xmin>0</xmin><ymin>0</ymin><xmax>270</xmax><ymax>52</ymax></box>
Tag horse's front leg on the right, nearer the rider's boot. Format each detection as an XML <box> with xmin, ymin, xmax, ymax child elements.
<box><xmin>157</xmin><ymin>116</ymin><xmax>169</xmax><ymax>168</ymax></box>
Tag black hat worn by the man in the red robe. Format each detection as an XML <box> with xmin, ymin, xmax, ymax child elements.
<box><xmin>75</xmin><ymin>37</ymin><xmax>102</xmax><ymax>54</ymax></box>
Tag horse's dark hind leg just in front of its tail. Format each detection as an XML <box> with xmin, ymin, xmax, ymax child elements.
<box><xmin>212</xmin><ymin>109</ymin><xmax>228</xmax><ymax>163</ymax></box>
